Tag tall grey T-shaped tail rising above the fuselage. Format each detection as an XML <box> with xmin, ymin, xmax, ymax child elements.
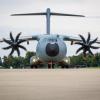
<box><xmin>11</xmin><ymin>8</ymin><xmax>85</xmax><ymax>34</ymax></box>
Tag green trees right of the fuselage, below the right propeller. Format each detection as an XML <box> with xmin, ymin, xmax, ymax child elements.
<box><xmin>70</xmin><ymin>53</ymin><xmax>100</xmax><ymax>67</ymax></box>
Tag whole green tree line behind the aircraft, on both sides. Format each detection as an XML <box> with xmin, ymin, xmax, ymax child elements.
<box><xmin>0</xmin><ymin>51</ymin><xmax>100</xmax><ymax>68</ymax></box>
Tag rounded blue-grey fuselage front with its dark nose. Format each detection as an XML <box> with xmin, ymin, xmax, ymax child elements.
<box><xmin>36</xmin><ymin>34</ymin><xmax>67</xmax><ymax>62</ymax></box>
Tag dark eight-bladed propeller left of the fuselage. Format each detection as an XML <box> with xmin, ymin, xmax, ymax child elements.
<box><xmin>3</xmin><ymin>32</ymin><xmax>27</xmax><ymax>56</ymax></box>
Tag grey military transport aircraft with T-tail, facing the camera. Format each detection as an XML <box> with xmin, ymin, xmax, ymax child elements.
<box><xmin>0</xmin><ymin>8</ymin><xmax>100</xmax><ymax>68</ymax></box>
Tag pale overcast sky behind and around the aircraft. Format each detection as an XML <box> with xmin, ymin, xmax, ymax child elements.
<box><xmin>0</xmin><ymin>0</ymin><xmax>100</xmax><ymax>56</ymax></box>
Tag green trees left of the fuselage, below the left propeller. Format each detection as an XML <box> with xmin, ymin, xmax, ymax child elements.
<box><xmin>0</xmin><ymin>51</ymin><xmax>36</xmax><ymax>68</ymax></box>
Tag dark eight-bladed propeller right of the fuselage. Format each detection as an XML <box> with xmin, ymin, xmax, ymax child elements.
<box><xmin>75</xmin><ymin>33</ymin><xmax>99</xmax><ymax>57</ymax></box>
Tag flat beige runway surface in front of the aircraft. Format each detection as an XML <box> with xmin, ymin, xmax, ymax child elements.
<box><xmin>0</xmin><ymin>69</ymin><xmax>100</xmax><ymax>100</ymax></box>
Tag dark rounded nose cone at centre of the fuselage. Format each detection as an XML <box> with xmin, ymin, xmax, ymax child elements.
<box><xmin>46</xmin><ymin>43</ymin><xmax>59</xmax><ymax>57</ymax></box>
